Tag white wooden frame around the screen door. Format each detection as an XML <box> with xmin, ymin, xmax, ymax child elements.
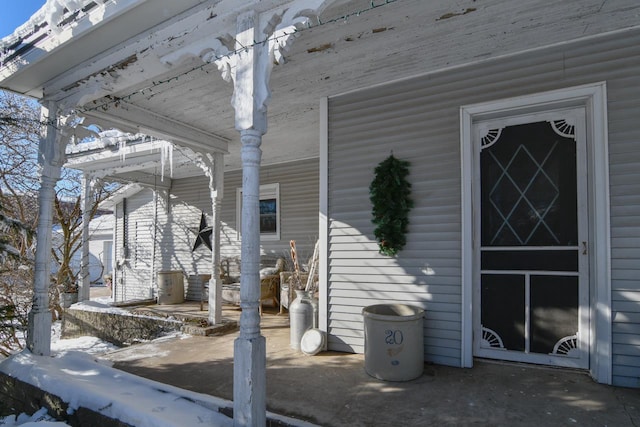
<box><xmin>460</xmin><ymin>82</ymin><xmax>612</xmax><ymax>384</ymax></box>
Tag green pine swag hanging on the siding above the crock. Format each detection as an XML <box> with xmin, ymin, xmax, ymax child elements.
<box><xmin>369</xmin><ymin>154</ymin><xmax>413</xmax><ymax>256</ymax></box>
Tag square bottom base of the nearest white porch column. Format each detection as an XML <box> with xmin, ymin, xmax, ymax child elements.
<box><xmin>233</xmin><ymin>336</ymin><xmax>267</xmax><ymax>426</ymax></box>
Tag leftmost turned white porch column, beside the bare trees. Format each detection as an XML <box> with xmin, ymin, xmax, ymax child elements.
<box><xmin>27</xmin><ymin>102</ymin><xmax>65</xmax><ymax>356</ymax></box>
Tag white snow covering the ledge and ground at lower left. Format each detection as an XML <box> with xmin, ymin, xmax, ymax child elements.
<box><xmin>0</xmin><ymin>298</ymin><xmax>233</xmax><ymax>427</ymax></box>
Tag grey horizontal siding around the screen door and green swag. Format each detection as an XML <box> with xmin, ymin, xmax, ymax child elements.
<box><xmin>327</xmin><ymin>23</ymin><xmax>640</xmax><ymax>378</ymax></box>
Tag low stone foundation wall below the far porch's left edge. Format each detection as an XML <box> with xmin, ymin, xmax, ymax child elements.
<box><xmin>61</xmin><ymin>308</ymin><xmax>182</xmax><ymax>347</ymax></box>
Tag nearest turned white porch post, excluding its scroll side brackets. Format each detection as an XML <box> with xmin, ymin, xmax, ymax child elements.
<box><xmin>232</xmin><ymin>11</ymin><xmax>273</xmax><ymax>426</ymax></box>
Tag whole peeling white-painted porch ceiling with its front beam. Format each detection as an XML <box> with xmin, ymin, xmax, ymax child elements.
<box><xmin>0</xmin><ymin>0</ymin><xmax>636</xmax><ymax>174</ymax></box>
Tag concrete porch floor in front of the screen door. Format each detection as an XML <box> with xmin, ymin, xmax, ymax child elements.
<box><xmin>91</xmin><ymin>290</ymin><xmax>640</xmax><ymax>426</ymax></box>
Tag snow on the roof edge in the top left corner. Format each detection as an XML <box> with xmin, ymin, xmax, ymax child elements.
<box><xmin>0</xmin><ymin>0</ymin><xmax>107</xmax><ymax>50</ymax></box>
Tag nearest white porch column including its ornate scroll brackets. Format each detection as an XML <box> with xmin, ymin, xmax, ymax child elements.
<box><xmin>191</xmin><ymin>0</ymin><xmax>326</xmax><ymax>426</ymax></box>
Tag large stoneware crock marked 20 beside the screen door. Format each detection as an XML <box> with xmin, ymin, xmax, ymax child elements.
<box><xmin>362</xmin><ymin>304</ymin><xmax>424</xmax><ymax>381</ymax></box>
